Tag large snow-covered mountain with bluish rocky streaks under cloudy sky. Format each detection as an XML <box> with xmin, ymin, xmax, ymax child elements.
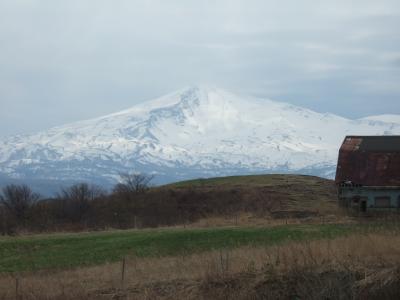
<box><xmin>0</xmin><ymin>87</ymin><xmax>400</xmax><ymax>195</ymax></box>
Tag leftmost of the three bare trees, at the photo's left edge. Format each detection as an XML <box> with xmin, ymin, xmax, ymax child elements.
<box><xmin>0</xmin><ymin>184</ymin><xmax>40</xmax><ymax>222</ymax></box>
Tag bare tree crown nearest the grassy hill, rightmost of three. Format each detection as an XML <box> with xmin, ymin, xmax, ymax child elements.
<box><xmin>114</xmin><ymin>173</ymin><xmax>154</xmax><ymax>194</ymax></box>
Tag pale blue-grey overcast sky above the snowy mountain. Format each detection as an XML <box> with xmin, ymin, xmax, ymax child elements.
<box><xmin>0</xmin><ymin>0</ymin><xmax>400</xmax><ymax>137</ymax></box>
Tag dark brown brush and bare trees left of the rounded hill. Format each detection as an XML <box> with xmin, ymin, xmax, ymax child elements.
<box><xmin>0</xmin><ymin>174</ymin><xmax>265</xmax><ymax>235</ymax></box>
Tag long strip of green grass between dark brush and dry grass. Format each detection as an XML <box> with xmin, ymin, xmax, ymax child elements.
<box><xmin>0</xmin><ymin>225</ymin><xmax>352</xmax><ymax>273</ymax></box>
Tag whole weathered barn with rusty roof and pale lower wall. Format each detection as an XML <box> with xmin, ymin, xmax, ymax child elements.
<box><xmin>335</xmin><ymin>136</ymin><xmax>400</xmax><ymax>212</ymax></box>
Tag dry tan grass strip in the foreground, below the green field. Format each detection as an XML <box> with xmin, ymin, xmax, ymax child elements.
<box><xmin>0</xmin><ymin>232</ymin><xmax>400</xmax><ymax>299</ymax></box>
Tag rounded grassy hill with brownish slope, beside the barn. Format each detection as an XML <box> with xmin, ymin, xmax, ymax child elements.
<box><xmin>162</xmin><ymin>174</ymin><xmax>338</xmax><ymax>218</ymax></box>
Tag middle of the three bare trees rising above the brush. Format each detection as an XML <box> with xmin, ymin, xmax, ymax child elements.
<box><xmin>58</xmin><ymin>183</ymin><xmax>106</xmax><ymax>221</ymax></box>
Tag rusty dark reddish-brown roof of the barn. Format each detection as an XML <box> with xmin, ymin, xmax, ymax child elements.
<box><xmin>335</xmin><ymin>136</ymin><xmax>400</xmax><ymax>186</ymax></box>
